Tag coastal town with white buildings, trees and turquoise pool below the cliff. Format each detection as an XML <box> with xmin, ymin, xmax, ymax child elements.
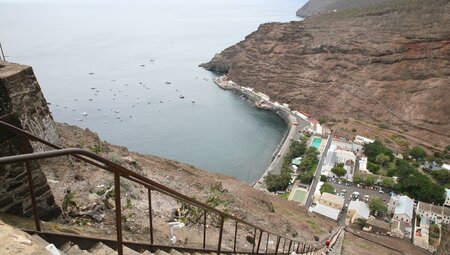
<box><xmin>214</xmin><ymin>75</ymin><xmax>450</xmax><ymax>253</ymax></box>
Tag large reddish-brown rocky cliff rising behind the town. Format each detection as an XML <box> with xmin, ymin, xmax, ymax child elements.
<box><xmin>202</xmin><ymin>0</ymin><xmax>450</xmax><ymax>148</ymax></box>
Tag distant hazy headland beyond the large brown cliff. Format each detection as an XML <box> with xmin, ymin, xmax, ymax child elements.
<box><xmin>296</xmin><ymin>0</ymin><xmax>391</xmax><ymax>18</ymax></box>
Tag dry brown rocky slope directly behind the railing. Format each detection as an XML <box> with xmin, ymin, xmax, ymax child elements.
<box><xmin>33</xmin><ymin>124</ymin><xmax>336</xmax><ymax>250</ymax></box>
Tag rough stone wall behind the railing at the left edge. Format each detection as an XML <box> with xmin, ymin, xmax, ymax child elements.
<box><xmin>0</xmin><ymin>61</ymin><xmax>61</xmax><ymax>219</ymax></box>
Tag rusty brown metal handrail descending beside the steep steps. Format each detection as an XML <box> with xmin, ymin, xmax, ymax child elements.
<box><xmin>0</xmin><ymin>121</ymin><xmax>320</xmax><ymax>255</ymax></box>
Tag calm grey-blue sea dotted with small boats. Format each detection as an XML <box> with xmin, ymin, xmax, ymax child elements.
<box><xmin>0</xmin><ymin>0</ymin><xmax>305</xmax><ymax>183</ymax></box>
